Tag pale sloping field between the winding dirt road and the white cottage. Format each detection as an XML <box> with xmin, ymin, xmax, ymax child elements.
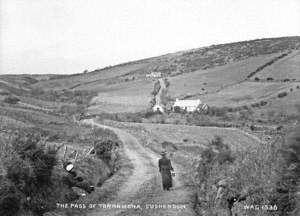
<box><xmin>108</xmin><ymin>122</ymin><xmax>261</xmax><ymax>157</ymax></box>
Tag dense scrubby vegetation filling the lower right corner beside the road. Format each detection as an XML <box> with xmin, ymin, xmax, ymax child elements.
<box><xmin>192</xmin><ymin>125</ymin><xmax>300</xmax><ymax>215</ymax></box>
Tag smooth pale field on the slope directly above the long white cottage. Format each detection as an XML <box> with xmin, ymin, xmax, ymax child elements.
<box><xmin>169</xmin><ymin>54</ymin><xmax>278</xmax><ymax>98</ymax></box>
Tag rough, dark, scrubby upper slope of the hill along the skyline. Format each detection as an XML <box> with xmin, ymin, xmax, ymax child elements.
<box><xmin>31</xmin><ymin>37</ymin><xmax>300</xmax><ymax>89</ymax></box>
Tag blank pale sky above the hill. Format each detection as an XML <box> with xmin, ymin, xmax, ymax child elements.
<box><xmin>0</xmin><ymin>0</ymin><xmax>300</xmax><ymax>74</ymax></box>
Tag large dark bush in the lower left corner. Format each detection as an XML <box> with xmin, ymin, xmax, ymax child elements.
<box><xmin>0</xmin><ymin>129</ymin><xmax>57</xmax><ymax>215</ymax></box>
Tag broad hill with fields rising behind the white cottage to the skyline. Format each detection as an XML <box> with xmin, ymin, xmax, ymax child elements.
<box><xmin>0</xmin><ymin>36</ymin><xmax>300</xmax><ymax>115</ymax></box>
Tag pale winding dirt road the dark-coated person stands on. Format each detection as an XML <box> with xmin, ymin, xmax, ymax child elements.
<box><xmin>85</xmin><ymin>120</ymin><xmax>194</xmax><ymax>216</ymax></box>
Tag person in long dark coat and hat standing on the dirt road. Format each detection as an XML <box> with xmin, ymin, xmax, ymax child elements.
<box><xmin>158</xmin><ymin>151</ymin><xmax>174</xmax><ymax>190</ymax></box>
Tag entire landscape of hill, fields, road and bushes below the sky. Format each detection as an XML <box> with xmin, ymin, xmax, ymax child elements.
<box><xmin>0</xmin><ymin>36</ymin><xmax>300</xmax><ymax>216</ymax></box>
